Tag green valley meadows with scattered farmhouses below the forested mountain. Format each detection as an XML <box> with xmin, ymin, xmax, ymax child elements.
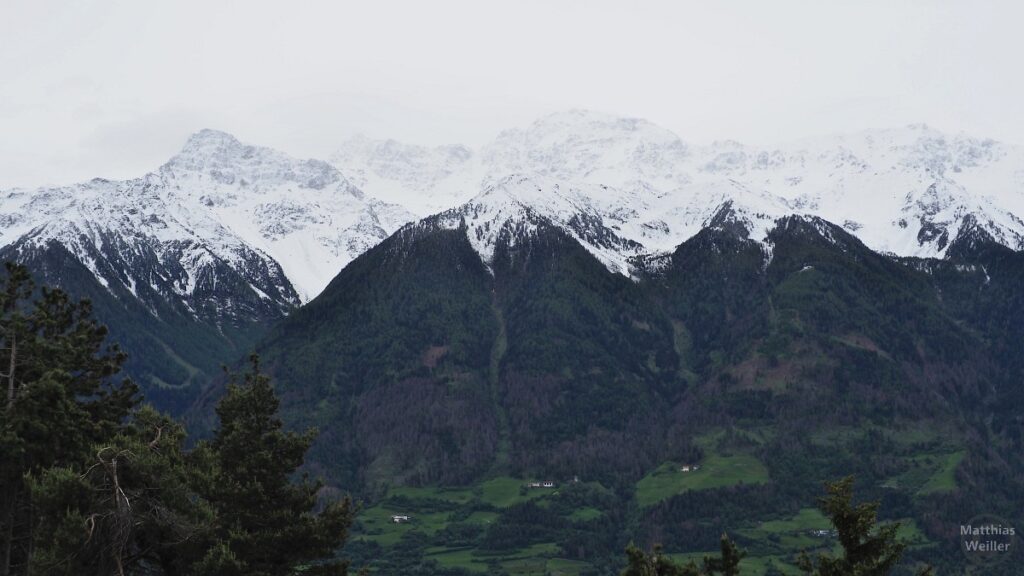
<box><xmin>350</xmin><ymin>427</ymin><xmax>950</xmax><ymax>576</ymax></box>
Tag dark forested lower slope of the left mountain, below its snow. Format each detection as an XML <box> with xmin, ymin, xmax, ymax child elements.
<box><xmin>0</xmin><ymin>238</ymin><xmax>288</xmax><ymax>416</ymax></box>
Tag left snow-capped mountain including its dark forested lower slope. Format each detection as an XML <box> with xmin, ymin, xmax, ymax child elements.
<box><xmin>0</xmin><ymin>130</ymin><xmax>412</xmax><ymax>399</ymax></box>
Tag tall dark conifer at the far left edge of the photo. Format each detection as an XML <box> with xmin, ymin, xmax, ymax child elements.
<box><xmin>0</xmin><ymin>262</ymin><xmax>138</xmax><ymax>576</ymax></box>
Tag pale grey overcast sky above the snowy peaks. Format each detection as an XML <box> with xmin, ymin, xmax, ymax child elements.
<box><xmin>0</xmin><ymin>0</ymin><xmax>1024</xmax><ymax>188</ymax></box>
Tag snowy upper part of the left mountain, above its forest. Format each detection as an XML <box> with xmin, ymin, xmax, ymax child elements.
<box><xmin>0</xmin><ymin>129</ymin><xmax>410</xmax><ymax>305</ymax></box>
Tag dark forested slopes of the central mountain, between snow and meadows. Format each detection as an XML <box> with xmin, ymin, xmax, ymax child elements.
<box><xmin>234</xmin><ymin>195</ymin><xmax>1016</xmax><ymax>484</ymax></box>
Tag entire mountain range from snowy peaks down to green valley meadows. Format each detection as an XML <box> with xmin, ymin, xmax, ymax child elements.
<box><xmin>6</xmin><ymin>112</ymin><xmax>1024</xmax><ymax>574</ymax></box>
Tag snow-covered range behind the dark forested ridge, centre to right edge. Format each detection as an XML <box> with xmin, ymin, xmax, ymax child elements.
<box><xmin>333</xmin><ymin>111</ymin><xmax>1024</xmax><ymax>274</ymax></box>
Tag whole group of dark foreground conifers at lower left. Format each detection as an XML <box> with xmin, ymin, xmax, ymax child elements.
<box><xmin>0</xmin><ymin>263</ymin><xmax>354</xmax><ymax>576</ymax></box>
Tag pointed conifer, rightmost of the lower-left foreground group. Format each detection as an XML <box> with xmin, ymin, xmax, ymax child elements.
<box><xmin>195</xmin><ymin>355</ymin><xmax>352</xmax><ymax>576</ymax></box>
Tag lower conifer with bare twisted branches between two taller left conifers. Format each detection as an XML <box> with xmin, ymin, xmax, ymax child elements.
<box><xmin>29</xmin><ymin>407</ymin><xmax>213</xmax><ymax>576</ymax></box>
